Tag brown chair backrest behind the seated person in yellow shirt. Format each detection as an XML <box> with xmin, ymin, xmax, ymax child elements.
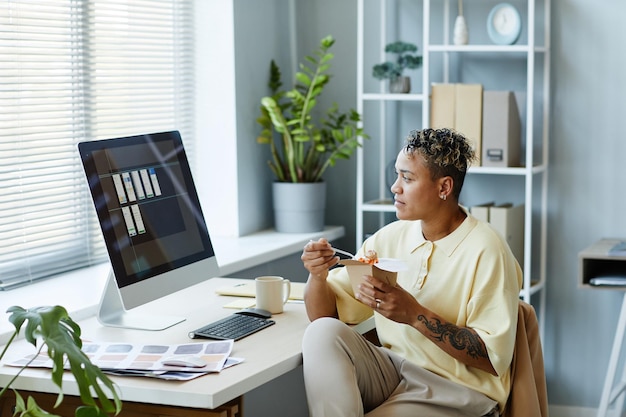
<box><xmin>503</xmin><ymin>300</ymin><xmax>548</xmax><ymax>417</ymax></box>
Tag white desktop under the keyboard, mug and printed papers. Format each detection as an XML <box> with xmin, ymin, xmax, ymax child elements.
<box><xmin>0</xmin><ymin>278</ymin><xmax>309</xmax><ymax>409</ymax></box>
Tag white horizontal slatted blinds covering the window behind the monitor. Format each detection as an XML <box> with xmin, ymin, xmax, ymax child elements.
<box><xmin>0</xmin><ymin>0</ymin><xmax>194</xmax><ymax>289</ymax></box>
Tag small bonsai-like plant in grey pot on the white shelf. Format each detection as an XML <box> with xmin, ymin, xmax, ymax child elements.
<box><xmin>372</xmin><ymin>41</ymin><xmax>422</xmax><ymax>93</ymax></box>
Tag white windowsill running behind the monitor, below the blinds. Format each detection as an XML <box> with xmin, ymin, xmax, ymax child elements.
<box><xmin>0</xmin><ymin>226</ymin><xmax>345</xmax><ymax>345</ymax></box>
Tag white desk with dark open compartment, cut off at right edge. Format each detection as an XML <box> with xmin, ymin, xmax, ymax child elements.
<box><xmin>578</xmin><ymin>239</ymin><xmax>626</xmax><ymax>417</ymax></box>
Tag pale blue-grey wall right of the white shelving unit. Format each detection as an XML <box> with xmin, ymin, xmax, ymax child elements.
<box><xmin>544</xmin><ymin>0</ymin><xmax>626</xmax><ymax>407</ymax></box>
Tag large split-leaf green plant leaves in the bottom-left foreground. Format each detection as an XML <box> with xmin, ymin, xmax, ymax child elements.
<box><xmin>0</xmin><ymin>306</ymin><xmax>122</xmax><ymax>417</ymax></box>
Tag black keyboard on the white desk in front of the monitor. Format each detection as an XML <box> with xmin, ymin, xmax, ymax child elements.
<box><xmin>189</xmin><ymin>313</ymin><xmax>276</xmax><ymax>340</ymax></box>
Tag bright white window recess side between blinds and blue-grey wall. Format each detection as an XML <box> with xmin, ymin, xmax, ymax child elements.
<box><xmin>193</xmin><ymin>0</ymin><xmax>240</xmax><ymax>237</ymax></box>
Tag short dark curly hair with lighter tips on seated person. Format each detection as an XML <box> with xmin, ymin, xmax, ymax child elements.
<box><xmin>403</xmin><ymin>128</ymin><xmax>475</xmax><ymax>200</ymax></box>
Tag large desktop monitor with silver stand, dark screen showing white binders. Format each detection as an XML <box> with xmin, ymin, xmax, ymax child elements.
<box><xmin>78</xmin><ymin>131</ymin><xmax>219</xmax><ymax>330</ymax></box>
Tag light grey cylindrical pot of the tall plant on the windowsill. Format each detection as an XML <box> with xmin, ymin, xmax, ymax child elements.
<box><xmin>272</xmin><ymin>182</ymin><xmax>326</xmax><ymax>233</ymax></box>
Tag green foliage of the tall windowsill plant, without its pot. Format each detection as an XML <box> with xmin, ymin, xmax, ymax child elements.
<box><xmin>257</xmin><ymin>36</ymin><xmax>368</xmax><ymax>182</ymax></box>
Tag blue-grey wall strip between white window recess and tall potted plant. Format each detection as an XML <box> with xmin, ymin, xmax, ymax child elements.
<box><xmin>235</xmin><ymin>0</ymin><xmax>293</xmax><ymax>234</ymax></box>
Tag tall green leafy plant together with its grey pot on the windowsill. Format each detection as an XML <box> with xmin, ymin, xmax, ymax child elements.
<box><xmin>257</xmin><ymin>36</ymin><xmax>367</xmax><ymax>233</ymax></box>
